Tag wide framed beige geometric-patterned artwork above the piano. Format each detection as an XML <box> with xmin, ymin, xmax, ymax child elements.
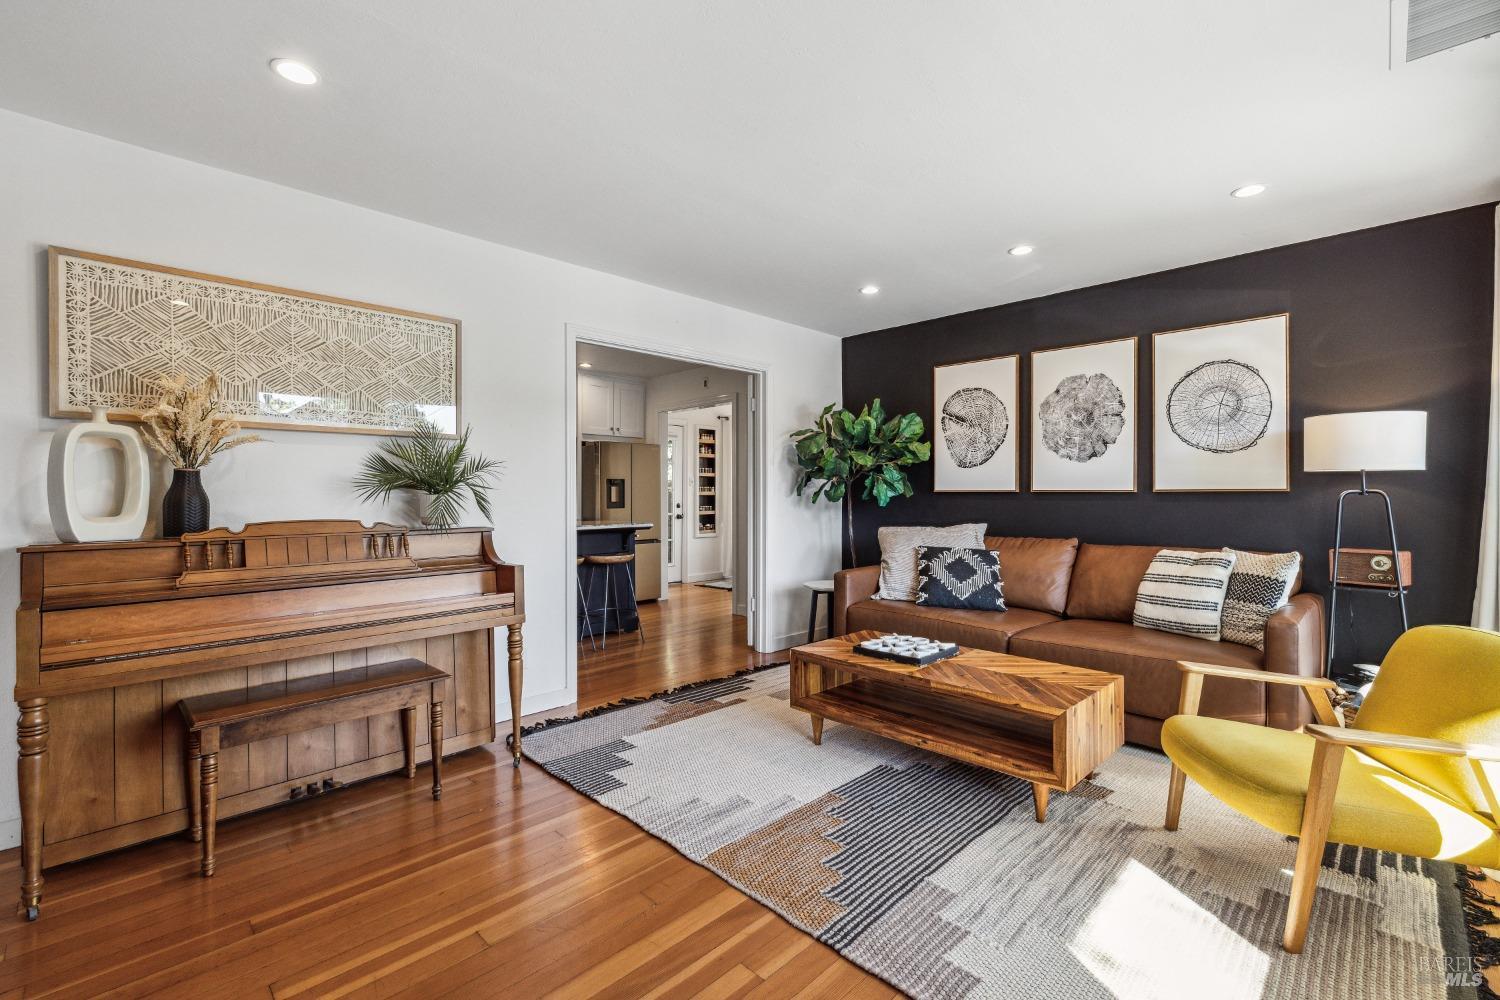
<box><xmin>48</xmin><ymin>247</ymin><xmax>461</xmax><ymax>433</ymax></box>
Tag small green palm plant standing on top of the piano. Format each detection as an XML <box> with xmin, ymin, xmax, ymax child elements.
<box><xmin>354</xmin><ymin>420</ymin><xmax>504</xmax><ymax>531</ymax></box>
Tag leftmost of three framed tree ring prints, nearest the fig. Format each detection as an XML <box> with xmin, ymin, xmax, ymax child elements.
<box><xmin>932</xmin><ymin>354</ymin><xmax>1022</xmax><ymax>493</ymax></box>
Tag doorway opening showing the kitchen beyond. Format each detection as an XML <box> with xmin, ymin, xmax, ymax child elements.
<box><xmin>569</xmin><ymin>327</ymin><xmax>770</xmax><ymax>711</ymax></box>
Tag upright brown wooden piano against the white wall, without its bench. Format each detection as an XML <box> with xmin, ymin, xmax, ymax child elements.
<box><xmin>15</xmin><ymin>520</ymin><xmax>525</xmax><ymax>919</ymax></box>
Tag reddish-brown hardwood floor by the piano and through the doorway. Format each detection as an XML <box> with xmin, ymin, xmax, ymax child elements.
<box><xmin>0</xmin><ymin>588</ymin><xmax>899</xmax><ymax>999</ymax></box>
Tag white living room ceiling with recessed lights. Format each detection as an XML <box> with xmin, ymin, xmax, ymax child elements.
<box><xmin>0</xmin><ymin>0</ymin><xmax>1500</xmax><ymax>334</ymax></box>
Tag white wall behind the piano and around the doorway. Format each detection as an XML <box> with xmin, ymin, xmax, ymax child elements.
<box><xmin>0</xmin><ymin>111</ymin><xmax>840</xmax><ymax>846</ymax></box>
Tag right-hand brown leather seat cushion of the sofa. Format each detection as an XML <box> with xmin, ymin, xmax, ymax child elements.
<box><xmin>1007</xmin><ymin>617</ymin><xmax>1266</xmax><ymax>724</ymax></box>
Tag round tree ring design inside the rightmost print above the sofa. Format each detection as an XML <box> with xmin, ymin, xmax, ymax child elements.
<box><xmin>1167</xmin><ymin>360</ymin><xmax>1272</xmax><ymax>454</ymax></box>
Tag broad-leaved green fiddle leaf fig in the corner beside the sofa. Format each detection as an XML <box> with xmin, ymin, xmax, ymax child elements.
<box><xmin>791</xmin><ymin>399</ymin><xmax>933</xmax><ymax>565</ymax></box>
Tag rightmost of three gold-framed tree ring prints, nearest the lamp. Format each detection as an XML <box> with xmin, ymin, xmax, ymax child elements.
<box><xmin>1151</xmin><ymin>312</ymin><xmax>1292</xmax><ymax>493</ymax></box>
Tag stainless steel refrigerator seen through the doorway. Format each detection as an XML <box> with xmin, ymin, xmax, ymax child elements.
<box><xmin>578</xmin><ymin>441</ymin><xmax>662</xmax><ymax>601</ymax></box>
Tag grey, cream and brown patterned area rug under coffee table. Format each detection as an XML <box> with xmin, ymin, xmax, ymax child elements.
<box><xmin>524</xmin><ymin>666</ymin><xmax>1493</xmax><ymax>1000</ymax></box>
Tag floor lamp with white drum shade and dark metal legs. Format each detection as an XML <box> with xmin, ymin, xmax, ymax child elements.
<box><xmin>1302</xmin><ymin>409</ymin><xmax>1427</xmax><ymax>676</ymax></box>
